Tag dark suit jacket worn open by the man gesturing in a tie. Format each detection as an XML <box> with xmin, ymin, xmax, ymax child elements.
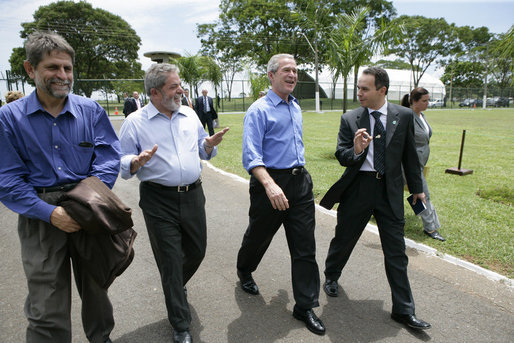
<box><xmin>320</xmin><ymin>103</ymin><xmax>423</xmax><ymax>218</ymax></box>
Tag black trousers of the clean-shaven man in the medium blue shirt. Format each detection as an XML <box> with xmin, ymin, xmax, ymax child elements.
<box><xmin>237</xmin><ymin>169</ymin><xmax>320</xmax><ymax>309</ymax></box>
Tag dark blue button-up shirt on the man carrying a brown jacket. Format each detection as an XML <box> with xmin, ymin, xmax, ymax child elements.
<box><xmin>0</xmin><ymin>91</ymin><xmax>121</xmax><ymax>222</ymax></box>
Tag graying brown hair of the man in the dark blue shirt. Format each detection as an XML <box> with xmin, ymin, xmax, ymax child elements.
<box><xmin>25</xmin><ymin>31</ymin><xmax>75</xmax><ymax>68</ymax></box>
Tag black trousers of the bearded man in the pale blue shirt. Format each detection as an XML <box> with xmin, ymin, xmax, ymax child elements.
<box><xmin>139</xmin><ymin>182</ymin><xmax>207</xmax><ymax>331</ymax></box>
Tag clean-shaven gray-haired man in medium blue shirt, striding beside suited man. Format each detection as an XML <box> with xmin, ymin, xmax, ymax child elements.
<box><xmin>237</xmin><ymin>54</ymin><xmax>325</xmax><ymax>335</ymax></box>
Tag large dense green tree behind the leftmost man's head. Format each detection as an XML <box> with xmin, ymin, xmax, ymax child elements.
<box><xmin>9</xmin><ymin>1</ymin><xmax>144</xmax><ymax>97</ymax></box>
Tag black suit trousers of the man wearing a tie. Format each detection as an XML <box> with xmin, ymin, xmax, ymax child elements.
<box><xmin>325</xmin><ymin>173</ymin><xmax>414</xmax><ymax>314</ymax></box>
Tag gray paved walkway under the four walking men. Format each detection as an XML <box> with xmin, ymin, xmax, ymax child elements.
<box><xmin>0</xmin><ymin>163</ymin><xmax>514</xmax><ymax>343</ymax></box>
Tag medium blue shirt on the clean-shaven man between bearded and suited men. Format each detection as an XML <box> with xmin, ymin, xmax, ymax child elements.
<box><xmin>243</xmin><ymin>90</ymin><xmax>305</xmax><ymax>173</ymax></box>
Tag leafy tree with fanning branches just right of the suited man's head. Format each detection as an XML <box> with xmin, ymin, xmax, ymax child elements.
<box><xmin>387</xmin><ymin>16</ymin><xmax>455</xmax><ymax>87</ymax></box>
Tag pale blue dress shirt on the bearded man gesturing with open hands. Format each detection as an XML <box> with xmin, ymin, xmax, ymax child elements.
<box><xmin>120</xmin><ymin>101</ymin><xmax>217</xmax><ymax>186</ymax></box>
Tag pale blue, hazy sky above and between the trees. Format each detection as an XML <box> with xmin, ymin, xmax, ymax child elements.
<box><xmin>0</xmin><ymin>0</ymin><xmax>514</xmax><ymax>96</ymax></box>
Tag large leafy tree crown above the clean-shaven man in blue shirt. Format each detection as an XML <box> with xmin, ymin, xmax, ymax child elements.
<box><xmin>198</xmin><ymin>0</ymin><xmax>395</xmax><ymax>70</ymax></box>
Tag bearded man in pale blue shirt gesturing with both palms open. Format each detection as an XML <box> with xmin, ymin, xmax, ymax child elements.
<box><xmin>120</xmin><ymin>63</ymin><xmax>228</xmax><ymax>342</ymax></box>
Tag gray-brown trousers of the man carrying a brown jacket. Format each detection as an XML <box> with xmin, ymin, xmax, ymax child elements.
<box><xmin>18</xmin><ymin>192</ymin><xmax>114</xmax><ymax>343</ymax></box>
